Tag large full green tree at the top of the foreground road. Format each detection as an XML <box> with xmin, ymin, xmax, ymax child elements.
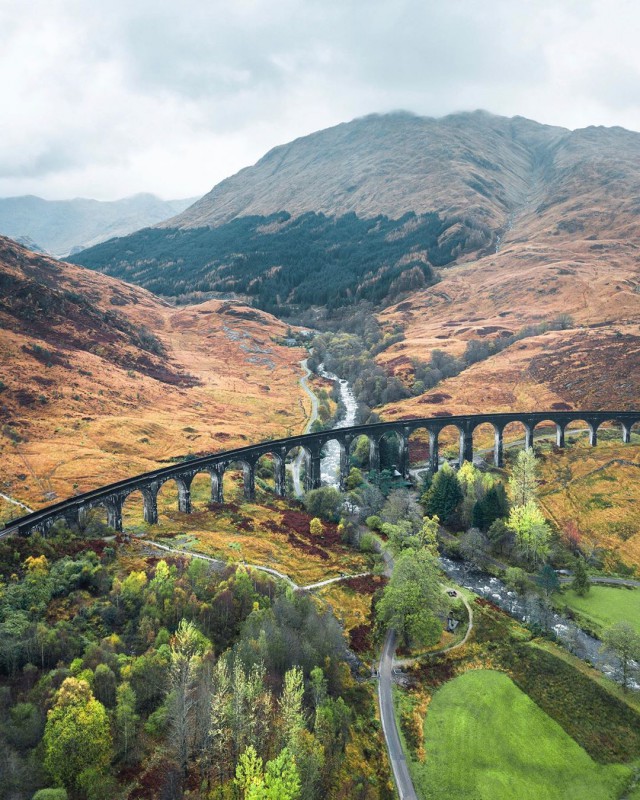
<box><xmin>376</xmin><ymin>548</ymin><xmax>444</xmax><ymax>646</ymax></box>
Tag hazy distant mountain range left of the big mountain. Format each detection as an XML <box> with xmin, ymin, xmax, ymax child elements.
<box><xmin>0</xmin><ymin>194</ymin><xmax>193</xmax><ymax>257</ymax></box>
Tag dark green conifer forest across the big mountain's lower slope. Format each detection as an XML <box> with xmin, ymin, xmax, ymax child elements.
<box><xmin>69</xmin><ymin>211</ymin><xmax>484</xmax><ymax>317</ymax></box>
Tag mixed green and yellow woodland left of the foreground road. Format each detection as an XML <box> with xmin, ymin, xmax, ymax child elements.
<box><xmin>0</xmin><ymin>521</ymin><xmax>391</xmax><ymax>800</ymax></box>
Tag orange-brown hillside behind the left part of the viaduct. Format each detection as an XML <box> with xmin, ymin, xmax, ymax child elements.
<box><xmin>0</xmin><ymin>238</ymin><xmax>306</xmax><ymax>516</ymax></box>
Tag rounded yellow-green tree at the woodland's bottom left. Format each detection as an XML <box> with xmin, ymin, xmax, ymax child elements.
<box><xmin>43</xmin><ymin>678</ymin><xmax>111</xmax><ymax>795</ymax></box>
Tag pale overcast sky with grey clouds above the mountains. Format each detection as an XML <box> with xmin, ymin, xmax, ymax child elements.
<box><xmin>0</xmin><ymin>0</ymin><xmax>640</xmax><ymax>200</ymax></box>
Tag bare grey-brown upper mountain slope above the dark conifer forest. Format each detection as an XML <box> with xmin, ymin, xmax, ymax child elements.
<box><xmin>161</xmin><ymin>111</ymin><xmax>569</xmax><ymax>229</ymax></box>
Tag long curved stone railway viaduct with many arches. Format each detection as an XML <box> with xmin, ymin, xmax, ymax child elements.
<box><xmin>0</xmin><ymin>411</ymin><xmax>640</xmax><ymax>537</ymax></box>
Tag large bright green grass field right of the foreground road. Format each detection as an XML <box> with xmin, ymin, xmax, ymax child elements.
<box><xmin>411</xmin><ymin>670</ymin><xmax>635</xmax><ymax>800</ymax></box>
